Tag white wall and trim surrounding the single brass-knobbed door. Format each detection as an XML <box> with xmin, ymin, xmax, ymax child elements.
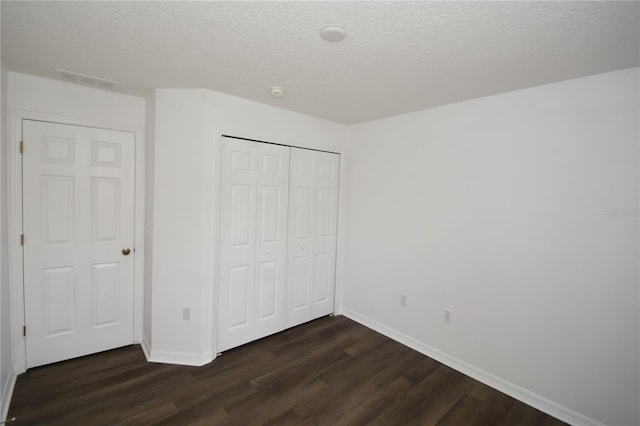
<box><xmin>7</xmin><ymin>71</ymin><xmax>145</xmax><ymax>373</ymax></box>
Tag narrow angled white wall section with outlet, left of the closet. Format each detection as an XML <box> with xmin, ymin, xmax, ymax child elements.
<box><xmin>150</xmin><ymin>90</ymin><xmax>211</xmax><ymax>365</ymax></box>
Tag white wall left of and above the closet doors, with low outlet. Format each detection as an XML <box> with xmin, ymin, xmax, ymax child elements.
<box><xmin>150</xmin><ymin>89</ymin><xmax>346</xmax><ymax>365</ymax></box>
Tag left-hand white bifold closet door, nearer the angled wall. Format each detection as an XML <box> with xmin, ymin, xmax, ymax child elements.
<box><xmin>218</xmin><ymin>137</ymin><xmax>289</xmax><ymax>351</ymax></box>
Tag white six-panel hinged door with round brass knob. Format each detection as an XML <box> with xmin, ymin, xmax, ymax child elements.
<box><xmin>23</xmin><ymin>120</ymin><xmax>135</xmax><ymax>367</ymax></box>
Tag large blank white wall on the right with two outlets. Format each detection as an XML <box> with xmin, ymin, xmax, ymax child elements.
<box><xmin>344</xmin><ymin>68</ymin><xmax>640</xmax><ymax>425</ymax></box>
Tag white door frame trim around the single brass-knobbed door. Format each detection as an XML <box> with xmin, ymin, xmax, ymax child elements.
<box><xmin>7</xmin><ymin>109</ymin><xmax>145</xmax><ymax>374</ymax></box>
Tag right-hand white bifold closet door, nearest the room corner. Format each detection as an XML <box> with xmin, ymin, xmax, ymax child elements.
<box><xmin>287</xmin><ymin>148</ymin><xmax>340</xmax><ymax>327</ymax></box>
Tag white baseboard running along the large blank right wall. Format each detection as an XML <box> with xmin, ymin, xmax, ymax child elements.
<box><xmin>341</xmin><ymin>307</ymin><xmax>604</xmax><ymax>426</ymax></box>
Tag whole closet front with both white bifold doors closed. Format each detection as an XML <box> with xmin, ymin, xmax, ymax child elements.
<box><xmin>217</xmin><ymin>136</ymin><xmax>340</xmax><ymax>352</ymax></box>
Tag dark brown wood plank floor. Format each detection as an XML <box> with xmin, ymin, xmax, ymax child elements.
<box><xmin>9</xmin><ymin>316</ymin><xmax>564</xmax><ymax>426</ymax></box>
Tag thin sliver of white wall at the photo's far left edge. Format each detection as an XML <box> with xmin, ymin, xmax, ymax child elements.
<box><xmin>0</xmin><ymin>63</ymin><xmax>16</xmax><ymax>421</ymax></box>
